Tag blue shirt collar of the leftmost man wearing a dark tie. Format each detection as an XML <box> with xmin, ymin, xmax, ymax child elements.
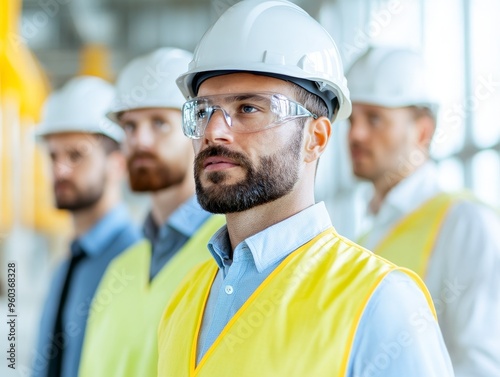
<box><xmin>76</xmin><ymin>204</ymin><xmax>129</xmax><ymax>257</ymax></box>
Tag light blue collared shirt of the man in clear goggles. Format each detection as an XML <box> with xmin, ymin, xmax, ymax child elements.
<box><xmin>197</xmin><ymin>203</ymin><xmax>453</xmax><ymax>377</ymax></box>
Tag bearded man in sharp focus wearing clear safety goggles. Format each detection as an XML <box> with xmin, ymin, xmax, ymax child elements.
<box><xmin>158</xmin><ymin>0</ymin><xmax>453</xmax><ymax>377</ymax></box>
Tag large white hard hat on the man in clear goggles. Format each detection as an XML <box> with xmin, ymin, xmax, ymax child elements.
<box><xmin>177</xmin><ymin>0</ymin><xmax>351</xmax><ymax>119</ymax></box>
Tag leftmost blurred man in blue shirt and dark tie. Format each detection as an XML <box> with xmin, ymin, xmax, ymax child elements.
<box><xmin>32</xmin><ymin>76</ymin><xmax>140</xmax><ymax>377</ymax></box>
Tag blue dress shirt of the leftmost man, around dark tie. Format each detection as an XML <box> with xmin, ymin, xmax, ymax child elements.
<box><xmin>32</xmin><ymin>205</ymin><xmax>141</xmax><ymax>377</ymax></box>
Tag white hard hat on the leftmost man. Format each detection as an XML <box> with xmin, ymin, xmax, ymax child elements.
<box><xmin>35</xmin><ymin>76</ymin><xmax>125</xmax><ymax>143</ymax></box>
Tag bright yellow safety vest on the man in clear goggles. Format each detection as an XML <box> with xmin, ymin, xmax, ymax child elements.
<box><xmin>158</xmin><ymin>228</ymin><xmax>435</xmax><ymax>377</ymax></box>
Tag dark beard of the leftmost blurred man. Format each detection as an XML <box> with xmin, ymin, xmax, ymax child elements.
<box><xmin>54</xmin><ymin>177</ymin><xmax>105</xmax><ymax>212</ymax></box>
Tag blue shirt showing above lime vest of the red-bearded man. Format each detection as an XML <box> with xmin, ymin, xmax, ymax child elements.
<box><xmin>143</xmin><ymin>195</ymin><xmax>211</xmax><ymax>280</ymax></box>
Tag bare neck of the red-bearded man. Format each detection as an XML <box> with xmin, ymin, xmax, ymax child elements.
<box><xmin>151</xmin><ymin>176</ymin><xmax>195</xmax><ymax>226</ymax></box>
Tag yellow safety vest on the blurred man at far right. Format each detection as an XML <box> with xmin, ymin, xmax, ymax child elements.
<box><xmin>373</xmin><ymin>192</ymin><xmax>473</xmax><ymax>279</ymax></box>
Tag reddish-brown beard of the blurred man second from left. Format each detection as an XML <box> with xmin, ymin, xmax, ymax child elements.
<box><xmin>127</xmin><ymin>152</ymin><xmax>186</xmax><ymax>192</ymax></box>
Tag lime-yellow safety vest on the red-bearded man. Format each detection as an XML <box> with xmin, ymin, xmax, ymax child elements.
<box><xmin>78</xmin><ymin>216</ymin><xmax>225</xmax><ymax>377</ymax></box>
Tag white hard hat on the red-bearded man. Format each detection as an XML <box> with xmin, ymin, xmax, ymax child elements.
<box><xmin>107</xmin><ymin>47</ymin><xmax>193</xmax><ymax>122</ymax></box>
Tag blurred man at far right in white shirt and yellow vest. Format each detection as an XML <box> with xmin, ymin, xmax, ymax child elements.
<box><xmin>348</xmin><ymin>48</ymin><xmax>500</xmax><ymax>377</ymax></box>
